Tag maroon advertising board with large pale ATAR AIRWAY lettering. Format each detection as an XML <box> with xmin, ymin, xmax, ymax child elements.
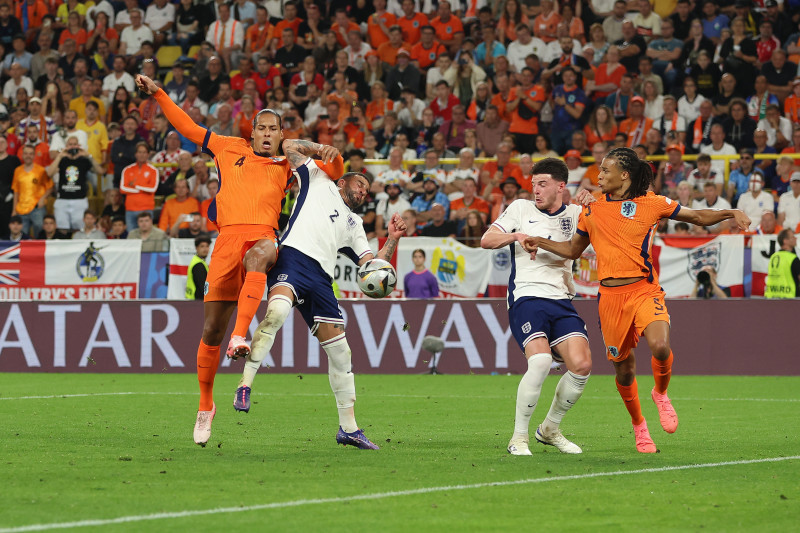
<box><xmin>0</xmin><ymin>298</ymin><xmax>800</xmax><ymax>374</ymax></box>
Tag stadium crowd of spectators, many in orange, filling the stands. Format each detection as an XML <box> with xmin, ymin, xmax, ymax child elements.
<box><xmin>0</xmin><ymin>0</ymin><xmax>800</xmax><ymax>247</ymax></box>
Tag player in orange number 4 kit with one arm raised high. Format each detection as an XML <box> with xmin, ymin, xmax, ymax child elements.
<box><xmin>136</xmin><ymin>75</ymin><xmax>343</xmax><ymax>446</ymax></box>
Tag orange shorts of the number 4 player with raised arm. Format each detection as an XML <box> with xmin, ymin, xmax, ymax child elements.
<box><xmin>203</xmin><ymin>224</ymin><xmax>278</xmax><ymax>302</ymax></box>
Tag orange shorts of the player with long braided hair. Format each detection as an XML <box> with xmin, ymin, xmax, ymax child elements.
<box><xmin>597</xmin><ymin>279</ymin><xmax>669</xmax><ymax>361</ymax></box>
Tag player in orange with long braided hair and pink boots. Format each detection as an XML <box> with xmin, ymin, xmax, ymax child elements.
<box><xmin>524</xmin><ymin>148</ymin><xmax>750</xmax><ymax>453</ymax></box>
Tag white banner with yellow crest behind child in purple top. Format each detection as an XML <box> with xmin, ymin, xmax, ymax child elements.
<box><xmin>395</xmin><ymin>237</ymin><xmax>490</xmax><ymax>298</ymax></box>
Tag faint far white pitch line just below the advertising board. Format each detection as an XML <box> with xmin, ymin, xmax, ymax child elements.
<box><xmin>0</xmin><ymin>391</ymin><xmax>800</xmax><ymax>402</ymax></box>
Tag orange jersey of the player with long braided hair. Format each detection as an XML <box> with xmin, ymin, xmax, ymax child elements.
<box><xmin>577</xmin><ymin>192</ymin><xmax>681</xmax><ymax>284</ymax></box>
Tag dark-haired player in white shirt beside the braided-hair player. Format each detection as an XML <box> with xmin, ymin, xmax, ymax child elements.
<box><xmin>481</xmin><ymin>158</ymin><xmax>592</xmax><ymax>455</ymax></box>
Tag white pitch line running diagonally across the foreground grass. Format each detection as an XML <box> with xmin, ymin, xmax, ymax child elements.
<box><xmin>0</xmin><ymin>455</ymin><xmax>800</xmax><ymax>533</ymax></box>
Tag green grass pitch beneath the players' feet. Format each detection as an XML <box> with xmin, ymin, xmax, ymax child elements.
<box><xmin>0</xmin><ymin>369</ymin><xmax>800</xmax><ymax>532</ymax></box>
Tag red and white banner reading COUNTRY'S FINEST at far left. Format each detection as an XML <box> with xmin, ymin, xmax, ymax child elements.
<box><xmin>0</xmin><ymin>240</ymin><xmax>142</xmax><ymax>300</ymax></box>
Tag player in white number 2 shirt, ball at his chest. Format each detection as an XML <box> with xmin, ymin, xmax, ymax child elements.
<box><xmin>233</xmin><ymin>139</ymin><xmax>406</xmax><ymax>450</ymax></box>
